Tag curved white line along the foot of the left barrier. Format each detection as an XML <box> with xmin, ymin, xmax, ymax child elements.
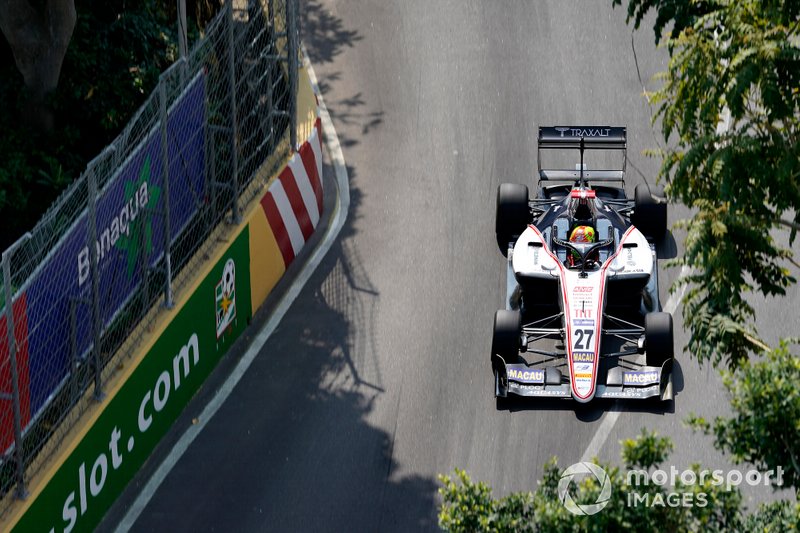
<box><xmin>117</xmin><ymin>46</ymin><xmax>350</xmax><ymax>531</ymax></box>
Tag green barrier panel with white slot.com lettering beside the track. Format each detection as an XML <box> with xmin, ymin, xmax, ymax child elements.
<box><xmin>15</xmin><ymin>228</ymin><xmax>251</xmax><ymax>532</ymax></box>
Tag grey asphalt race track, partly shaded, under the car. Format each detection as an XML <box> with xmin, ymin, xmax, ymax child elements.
<box><xmin>103</xmin><ymin>0</ymin><xmax>800</xmax><ymax>531</ymax></box>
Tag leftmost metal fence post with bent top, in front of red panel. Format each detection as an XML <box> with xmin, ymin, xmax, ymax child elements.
<box><xmin>3</xmin><ymin>233</ymin><xmax>31</xmax><ymax>500</ymax></box>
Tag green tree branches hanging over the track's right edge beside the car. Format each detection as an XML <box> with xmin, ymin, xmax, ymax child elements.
<box><xmin>614</xmin><ymin>0</ymin><xmax>800</xmax><ymax>367</ymax></box>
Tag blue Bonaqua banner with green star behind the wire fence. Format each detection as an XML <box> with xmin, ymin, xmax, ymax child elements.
<box><xmin>23</xmin><ymin>74</ymin><xmax>207</xmax><ymax>416</ymax></box>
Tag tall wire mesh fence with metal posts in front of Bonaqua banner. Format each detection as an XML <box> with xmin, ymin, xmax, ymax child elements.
<box><xmin>0</xmin><ymin>0</ymin><xmax>298</xmax><ymax>514</ymax></box>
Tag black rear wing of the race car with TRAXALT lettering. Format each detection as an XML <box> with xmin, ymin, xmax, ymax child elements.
<box><xmin>536</xmin><ymin>126</ymin><xmax>628</xmax><ymax>186</ymax></box>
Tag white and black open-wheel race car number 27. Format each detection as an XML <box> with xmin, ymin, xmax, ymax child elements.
<box><xmin>491</xmin><ymin>126</ymin><xmax>674</xmax><ymax>407</ymax></box>
